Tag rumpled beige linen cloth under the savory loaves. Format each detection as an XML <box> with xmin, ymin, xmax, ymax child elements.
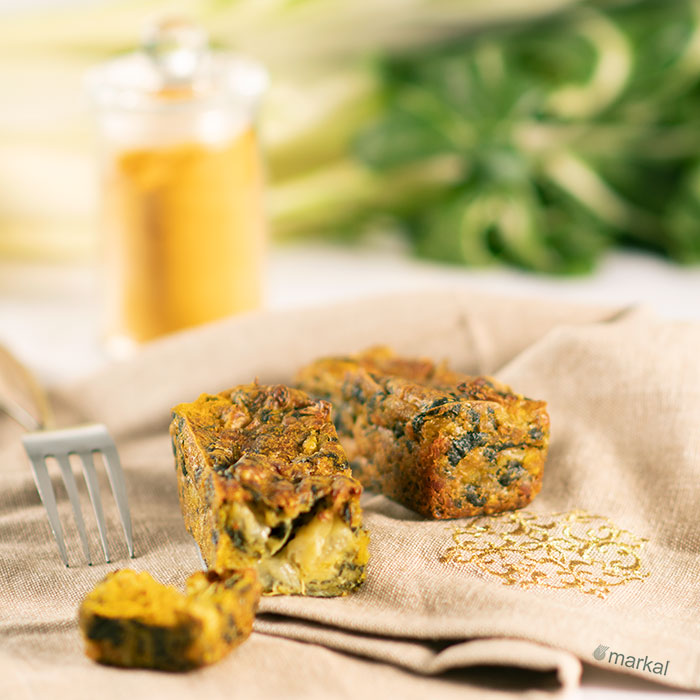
<box><xmin>0</xmin><ymin>291</ymin><xmax>700</xmax><ymax>700</ymax></box>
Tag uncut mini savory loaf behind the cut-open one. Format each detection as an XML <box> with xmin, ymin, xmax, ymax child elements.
<box><xmin>297</xmin><ymin>348</ymin><xmax>549</xmax><ymax>518</ymax></box>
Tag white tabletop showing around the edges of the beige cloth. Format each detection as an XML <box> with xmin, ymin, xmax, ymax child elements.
<box><xmin>0</xmin><ymin>242</ymin><xmax>700</xmax><ymax>700</ymax></box>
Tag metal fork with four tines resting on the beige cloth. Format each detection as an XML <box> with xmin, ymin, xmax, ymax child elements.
<box><xmin>0</xmin><ymin>348</ymin><xmax>134</xmax><ymax>566</ymax></box>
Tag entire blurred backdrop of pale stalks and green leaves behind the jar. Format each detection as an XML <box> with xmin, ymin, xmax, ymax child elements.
<box><xmin>0</xmin><ymin>0</ymin><xmax>700</xmax><ymax>273</ymax></box>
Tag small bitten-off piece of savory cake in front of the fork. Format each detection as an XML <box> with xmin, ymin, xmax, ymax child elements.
<box><xmin>79</xmin><ymin>569</ymin><xmax>260</xmax><ymax>671</ymax></box>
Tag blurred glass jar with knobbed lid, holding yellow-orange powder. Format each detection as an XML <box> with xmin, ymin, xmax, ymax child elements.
<box><xmin>91</xmin><ymin>22</ymin><xmax>266</xmax><ymax>354</ymax></box>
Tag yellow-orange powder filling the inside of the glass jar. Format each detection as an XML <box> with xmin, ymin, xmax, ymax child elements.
<box><xmin>104</xmin><ymin>130</ymin><xmax>265</xmax><ymax>341</ymax></box>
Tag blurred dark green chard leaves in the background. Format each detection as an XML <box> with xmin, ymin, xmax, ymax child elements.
<box><xmin>353</xmin><ymin>0</ymin><xmax>700</xmax><ymax>273</ymax></box>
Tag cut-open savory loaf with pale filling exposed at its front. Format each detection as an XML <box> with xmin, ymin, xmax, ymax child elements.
<box><xmin>170</xmin><ymin>383</ymin><xmax>368</xmax><ymax>596</ymax></box>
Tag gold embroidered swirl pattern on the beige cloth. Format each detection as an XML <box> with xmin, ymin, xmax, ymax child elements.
<box><xmin>440</xmin><ymin>510</ymin><xmax>649</xmax><ymax>598</ymax></box>
